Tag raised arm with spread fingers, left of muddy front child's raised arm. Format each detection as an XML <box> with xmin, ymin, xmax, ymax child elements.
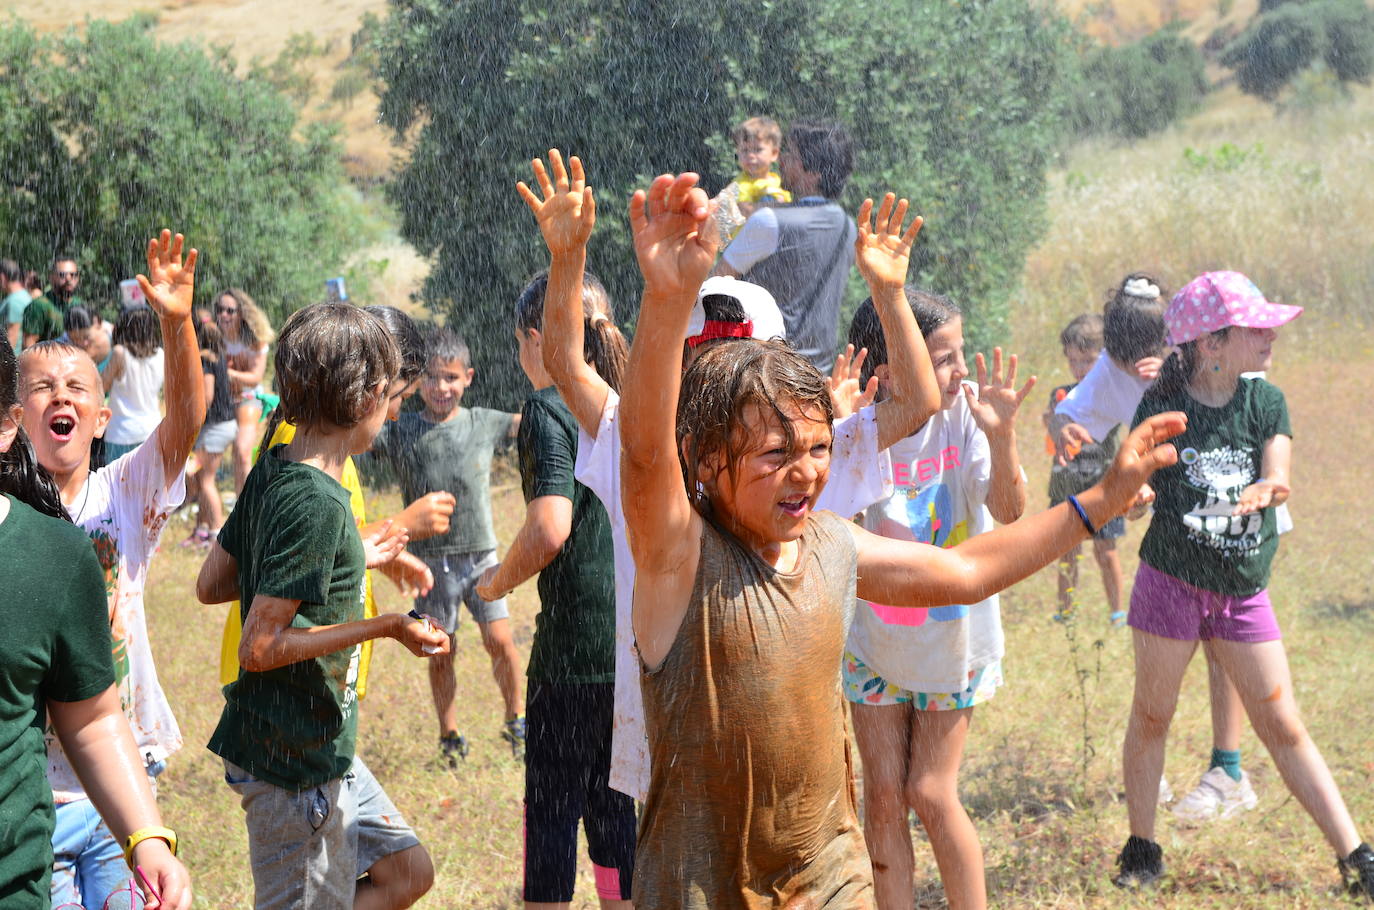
<box><xmin>515</xmin><ymin>148</ymin><xmax>610</xmax><ymax>439</ymax></box>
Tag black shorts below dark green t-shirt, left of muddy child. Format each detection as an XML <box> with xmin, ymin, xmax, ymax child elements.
<box><xmin>525</xmin><ymin>679</ymin><xmax>635</xmax><ymax>903</ymax></box>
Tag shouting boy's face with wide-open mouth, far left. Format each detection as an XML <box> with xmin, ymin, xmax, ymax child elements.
<box><xmin>19</xmin><ymin>352</ymin><xmax>110</xmax><ymax>476</ymax></box>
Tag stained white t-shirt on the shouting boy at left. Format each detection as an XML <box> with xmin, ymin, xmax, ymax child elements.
<box><xmin>47</xmin><ymin>437</ymin><xmax>185</xmax><ymax>803</ymax></box>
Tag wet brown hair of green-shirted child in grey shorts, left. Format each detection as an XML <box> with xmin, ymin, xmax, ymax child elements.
<box><xmin>268</xmin><ymin>304</ymin><xmax>401</xmax><ymax>439</ymax></box>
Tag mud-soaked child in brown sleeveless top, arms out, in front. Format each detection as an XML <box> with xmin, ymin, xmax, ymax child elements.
<box><xmin>621</xmin><ymin>175</ymin><xmax>1182</xmax><ymax>910</ymax></box>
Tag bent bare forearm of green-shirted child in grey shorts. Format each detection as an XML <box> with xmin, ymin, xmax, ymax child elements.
<box><xmin>239</xmin><ymin>594</ymin><xmax>448</xmax><ymax>672</ymax></box>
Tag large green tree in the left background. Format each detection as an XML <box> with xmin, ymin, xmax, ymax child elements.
<box><xmin>0</xmin><ymin>18</ymin><xmax>363</xmax><ymax>320</ymax></box>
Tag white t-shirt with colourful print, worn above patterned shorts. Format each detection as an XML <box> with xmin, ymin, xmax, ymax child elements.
<box><xmin>848</xmin><ymin>395</ymin><xmax>1004</xmax><ymax>693</ymax></box>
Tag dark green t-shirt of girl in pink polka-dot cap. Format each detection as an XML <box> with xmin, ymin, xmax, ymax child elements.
<box><xmin>1134</xmin><ymin>379</ymin><xmax>1293</xmax><ymax>597</ymax></box>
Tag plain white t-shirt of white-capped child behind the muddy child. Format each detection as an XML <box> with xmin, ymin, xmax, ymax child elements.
<box><xmin>573</xmin><ymin>390</ymin><xmax>892</xmax><ymax>800</ymax></box>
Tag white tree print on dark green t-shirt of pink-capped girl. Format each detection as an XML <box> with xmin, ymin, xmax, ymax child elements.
<box><xmin>1179</xmin><ymin>445</ymin><xmax>1264</xmax><ymax>555</ymax></box>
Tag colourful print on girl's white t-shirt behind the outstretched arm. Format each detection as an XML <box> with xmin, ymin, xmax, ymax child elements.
<box><xmin>870</xmin><ymin>445</ymin><xmax>969</xmax><ymax>625</ymax></box>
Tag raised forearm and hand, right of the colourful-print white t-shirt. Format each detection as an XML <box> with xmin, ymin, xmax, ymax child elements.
<box><xmin>963</xmin><ymin>348</ymin><xmax>1036</xmax><ymax>525</ymax></box>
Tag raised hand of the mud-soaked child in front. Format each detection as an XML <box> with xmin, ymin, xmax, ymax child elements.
<box><xmin>629</xmin><ymin>173</ymin><xmax>720</xmax><ymax>301</ymax></box>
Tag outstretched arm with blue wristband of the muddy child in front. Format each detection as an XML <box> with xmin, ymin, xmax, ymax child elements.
<box><xmin>851</xmin><ymin>412</ymin><xmax>1186</xmax><ymax>606</ymax></box>
